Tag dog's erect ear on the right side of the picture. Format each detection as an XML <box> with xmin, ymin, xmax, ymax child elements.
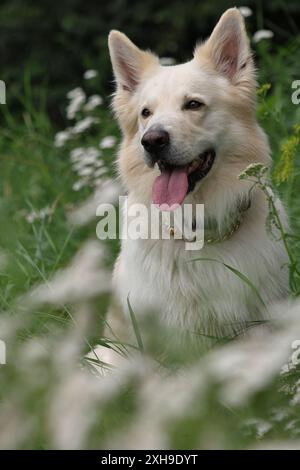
<box><xmin>196</xmin><ymin>8</ymin><xmax>252</xmax><ymax>82</ymax></box>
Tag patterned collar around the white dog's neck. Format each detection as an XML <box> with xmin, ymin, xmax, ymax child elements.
<box><xmin>167</xmin><ymin>198</ymin><xmax>251</xmax><ymax>245</ymax></box>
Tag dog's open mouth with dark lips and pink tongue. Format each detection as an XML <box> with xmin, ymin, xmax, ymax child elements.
<box><xmin>152</xmin><ymin>149</ymin><xmax>216</xmax><ymax>210</ymax></box>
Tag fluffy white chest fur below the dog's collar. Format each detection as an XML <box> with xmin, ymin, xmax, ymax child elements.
<box><xmin>115</xmin><ymin>193</ymin><xmax>288</xmax><ymax>336</ymax></box>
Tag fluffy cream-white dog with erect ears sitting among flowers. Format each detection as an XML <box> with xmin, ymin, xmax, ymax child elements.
<box><xmin>108</xmin><ymin>8</ymin><xmax>288</xmax><ymax>346</ymax></box>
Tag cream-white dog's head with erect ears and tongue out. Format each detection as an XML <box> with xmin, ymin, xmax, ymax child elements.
<box><xmin>109</xmin><ymin>8</ymin><xmax>268</xmax><ymax>209</ymax></box>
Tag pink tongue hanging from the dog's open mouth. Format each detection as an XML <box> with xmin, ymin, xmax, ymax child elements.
<box><xmin>152</xmin><ymin>167</ymin><xmax>189</xmax><ymax>210</ymax></box>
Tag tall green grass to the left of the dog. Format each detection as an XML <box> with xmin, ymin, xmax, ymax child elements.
<box><xmin>0</xmin><ymin>82</ymin><xmax>116</xmax><ymax>296</ymax></box>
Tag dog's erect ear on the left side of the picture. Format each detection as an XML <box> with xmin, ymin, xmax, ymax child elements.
<box><xmin>108</xmin><ymin>31</ymin><xmax>158</xmax><ymax>92</ymax></box>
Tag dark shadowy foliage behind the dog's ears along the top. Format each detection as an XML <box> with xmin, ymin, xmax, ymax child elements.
<box><xmin>0</xmin><ymin>0</ymin><xmax>300</xmax><ymax>123</ymax></box>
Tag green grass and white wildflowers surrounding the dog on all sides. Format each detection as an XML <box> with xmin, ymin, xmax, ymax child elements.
<box><xmin>0</xmin><ymin>0</ymin><xmax>300</xmax><ymax>448</ymax></box>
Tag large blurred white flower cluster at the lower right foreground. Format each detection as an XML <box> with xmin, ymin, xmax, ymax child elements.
<box><xmin>206</xmin><ymin>302</ymin><xmax>300</xmax><ymax>405</ymax></box>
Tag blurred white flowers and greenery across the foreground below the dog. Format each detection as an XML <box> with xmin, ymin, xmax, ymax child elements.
<box><xmin>0</xmin><ymin>280</ymin><xmax>300</xmax><ymax>449</ymax></box>
